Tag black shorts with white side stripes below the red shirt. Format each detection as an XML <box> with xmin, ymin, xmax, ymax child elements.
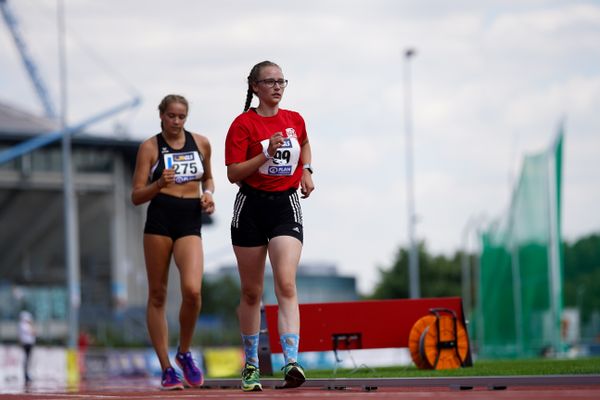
<box><xmin>231</xmin><ymin>185</ymin><xmax>304</xmax><ymax>247</ymax></box>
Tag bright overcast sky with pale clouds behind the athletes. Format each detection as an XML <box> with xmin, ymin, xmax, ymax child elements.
<box><xmin>0</xmin><ymin>0</ymin><xmax>600</xmax><ymax>293</ymax></box>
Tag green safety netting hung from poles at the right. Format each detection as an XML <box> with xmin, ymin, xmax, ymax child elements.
<box><xmin>472</xmin><ymin>129</ymin><xmax>563</xmax><ymax>358</ymax></box>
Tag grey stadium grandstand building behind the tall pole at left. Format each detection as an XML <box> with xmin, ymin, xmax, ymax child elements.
<box><xmin>0</xmin><ymin>103</ymin><xmax>147</xmax><ymax>341</ymax></box>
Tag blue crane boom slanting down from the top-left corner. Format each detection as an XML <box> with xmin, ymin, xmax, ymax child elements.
<box><xmin>0</xmin><ymin>0</ymin><xmax>57</xmax><ymax>119</ymax></box>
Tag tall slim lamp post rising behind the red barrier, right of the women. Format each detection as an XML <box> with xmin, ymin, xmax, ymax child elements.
<box><xmin>404</xmin><ymin>48</ymin><xmax>421</xmax><ymax>299</ymax></box>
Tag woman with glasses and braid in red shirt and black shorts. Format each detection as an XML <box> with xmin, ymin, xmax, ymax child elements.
<box><xmin>225</xmin><ymin>61</ymin><xmax>314</xmax><ymax>391</ymax></box>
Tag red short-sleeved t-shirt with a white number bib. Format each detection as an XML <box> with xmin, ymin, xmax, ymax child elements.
<box><xmin>225</xmin><ymin>109</ymin><xmax>308</xmax><ymax>192</ymax></box>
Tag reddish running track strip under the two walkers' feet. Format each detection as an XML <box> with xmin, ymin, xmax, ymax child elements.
<box><xmin>0</xmin><ymin>375</ymin><xmax>600</xmax><ymax>400</ymax></box>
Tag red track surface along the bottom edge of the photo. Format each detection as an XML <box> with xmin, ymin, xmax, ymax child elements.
<box><xmin>0</xmin><ymin>376</ymin><xmax>600</xmax><ymax>400</ymax></box>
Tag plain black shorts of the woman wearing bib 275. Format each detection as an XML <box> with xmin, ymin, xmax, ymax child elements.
<box><xmin>144</xmin><ymin>193</ymin><xmax>202</xmax><ymax>241</ymax></box>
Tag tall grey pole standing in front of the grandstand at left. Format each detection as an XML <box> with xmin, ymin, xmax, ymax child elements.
<box><xmin>57</xmin><ymin>0</ymin><xmax>81</xmax><ymax>349</ymax></box>
